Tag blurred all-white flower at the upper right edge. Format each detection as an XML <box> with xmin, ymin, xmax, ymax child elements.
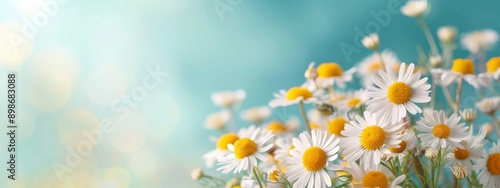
<box><xmin>462</xmin><ymin>29</ymin><xmax>498</xmax><ymax>53</ymax></box>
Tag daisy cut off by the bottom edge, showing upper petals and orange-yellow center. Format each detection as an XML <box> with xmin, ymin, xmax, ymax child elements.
<box><xmin>344</xmin><ymin>162</ymin><xmax>406</xmax><ymax>188</ymax></box>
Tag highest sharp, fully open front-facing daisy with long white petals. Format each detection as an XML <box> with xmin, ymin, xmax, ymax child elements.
<box><xmin>366</xmin><ymin>63</ymin><xmax>431</xmax><ymax>124</ymax></box>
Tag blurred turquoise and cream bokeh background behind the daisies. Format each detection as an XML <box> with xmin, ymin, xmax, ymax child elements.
<box><xmin>0</xmin><ymin>0</ymin><xmax>500</xmax><ymax>188</ymax></box>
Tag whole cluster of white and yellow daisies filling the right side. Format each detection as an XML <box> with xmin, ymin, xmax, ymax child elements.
<box><xmin>191</xmin><ymin>0</ymin><xmax>500</xmax><ymax>188</ymax></box>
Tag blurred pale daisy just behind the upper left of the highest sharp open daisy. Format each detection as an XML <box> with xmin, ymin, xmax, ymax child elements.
<box><xmin>357</xmin><ymin>50</ymin><xmax>401</xmax><ymax>87</ymax></box>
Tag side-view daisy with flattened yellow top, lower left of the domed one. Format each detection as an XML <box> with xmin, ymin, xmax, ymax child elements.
<box><xmin>269</xmin><ymin>87</ymin><xmax>317</xmax><ymax>108</ymax></box>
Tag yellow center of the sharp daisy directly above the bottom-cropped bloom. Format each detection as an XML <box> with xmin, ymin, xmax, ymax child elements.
<box><xmin>361</xmin><ymin>125</ymin><xmax>385</xmax><ymax>150</ymax></box>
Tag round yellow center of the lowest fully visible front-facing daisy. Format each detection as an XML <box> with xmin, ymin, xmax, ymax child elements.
<box><xmin>302</xmin><ymin>146</ymin><xmax>328</xmax><ymax>172</ymax></box>
